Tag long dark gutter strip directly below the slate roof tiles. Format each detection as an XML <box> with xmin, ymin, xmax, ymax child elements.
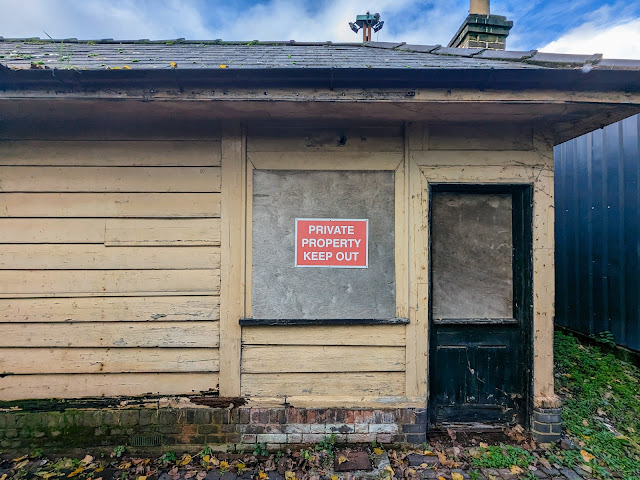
<box><xmin>0</xmin><ymin>68</ymin><xmax>640</xmax><ymax>93</ymax></box>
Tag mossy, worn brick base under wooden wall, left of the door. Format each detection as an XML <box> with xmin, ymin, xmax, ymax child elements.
<box><xmin>0</xmin><ymin>407</ymin><xmax>427</xmax><ymax>451</ymax></box>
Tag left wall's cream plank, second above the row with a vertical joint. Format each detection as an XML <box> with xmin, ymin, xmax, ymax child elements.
<box><xmin>0</xmin><ymin>166</ymin><xmax>220</xmax><ymax>192</ymax></box>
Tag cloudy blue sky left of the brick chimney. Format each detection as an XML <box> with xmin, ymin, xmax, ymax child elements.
<box><xmin>0</xmin><ymin>0</ymin><xmax>468</xmax><ymax>44</ymax></box>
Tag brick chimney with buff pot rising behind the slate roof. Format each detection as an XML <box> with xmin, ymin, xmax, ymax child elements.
<box><xmin>448</xmin><ymin>0</ymin><xmax>513</xmax><ymax>50</ymax></box>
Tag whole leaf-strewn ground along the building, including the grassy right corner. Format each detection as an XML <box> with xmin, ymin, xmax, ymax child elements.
<box><xmin>0</xmin><ymin>333</ymin><xmax>640</xmax><ymax>480</ymax></box>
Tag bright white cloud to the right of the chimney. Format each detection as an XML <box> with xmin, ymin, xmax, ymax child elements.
<box><xmin>539</xmin><ymin>18</ymin><xmax>640</xmax><ymax>59</ymax></box>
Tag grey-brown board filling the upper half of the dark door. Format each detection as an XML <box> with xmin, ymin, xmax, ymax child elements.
<box><xmin>431</xmin><ymin>193</ymin><xmax>513</xmax><ymax>319</ymax></box>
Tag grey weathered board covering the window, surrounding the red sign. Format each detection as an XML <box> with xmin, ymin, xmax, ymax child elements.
<box><xmin>252</xmin><ymin>170</ymin><xmax>395</xmax><ymax>319</ymax></box>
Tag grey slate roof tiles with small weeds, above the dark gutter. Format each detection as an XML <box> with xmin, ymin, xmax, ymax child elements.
<box><xmin>0</xmin><ymin>37</ymin><xmax>640</xmax><ymax>71</ymax></box>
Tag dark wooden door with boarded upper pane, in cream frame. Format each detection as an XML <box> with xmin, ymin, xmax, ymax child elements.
<box><xmin>429</xmin><ymin>186</ymin><xmax>532</xmax><ymax>426</ymax></box>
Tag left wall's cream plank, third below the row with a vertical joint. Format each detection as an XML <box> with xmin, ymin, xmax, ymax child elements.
<box><xmin>0</xmin><ymin>296</ymin><xmax>220</xmax><ymax>322</ymax></box>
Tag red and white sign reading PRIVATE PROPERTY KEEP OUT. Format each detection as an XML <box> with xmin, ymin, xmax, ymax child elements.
<box><xmin>296</xmin><ymin>218</ymin><xmax>369</xmax><ymax>268</ymax></box>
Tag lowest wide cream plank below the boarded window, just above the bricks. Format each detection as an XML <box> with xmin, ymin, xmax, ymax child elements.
<box><xmin>242</xmin><ymin>372</ymin><xmax>405</xmax><ymax>398</ymax></box>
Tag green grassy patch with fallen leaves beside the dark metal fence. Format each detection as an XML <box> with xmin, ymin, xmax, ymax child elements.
<box><xmin>554</xmin><ymin>332</ymin><xmax>640</xmax><ymax>479</ymax></box>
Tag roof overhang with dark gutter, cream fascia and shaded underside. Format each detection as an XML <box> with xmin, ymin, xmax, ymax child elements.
<box><xmin>0</xmin><ymin>68</ymin><xmax>640</xmax><ymax>143</ymax></box>
